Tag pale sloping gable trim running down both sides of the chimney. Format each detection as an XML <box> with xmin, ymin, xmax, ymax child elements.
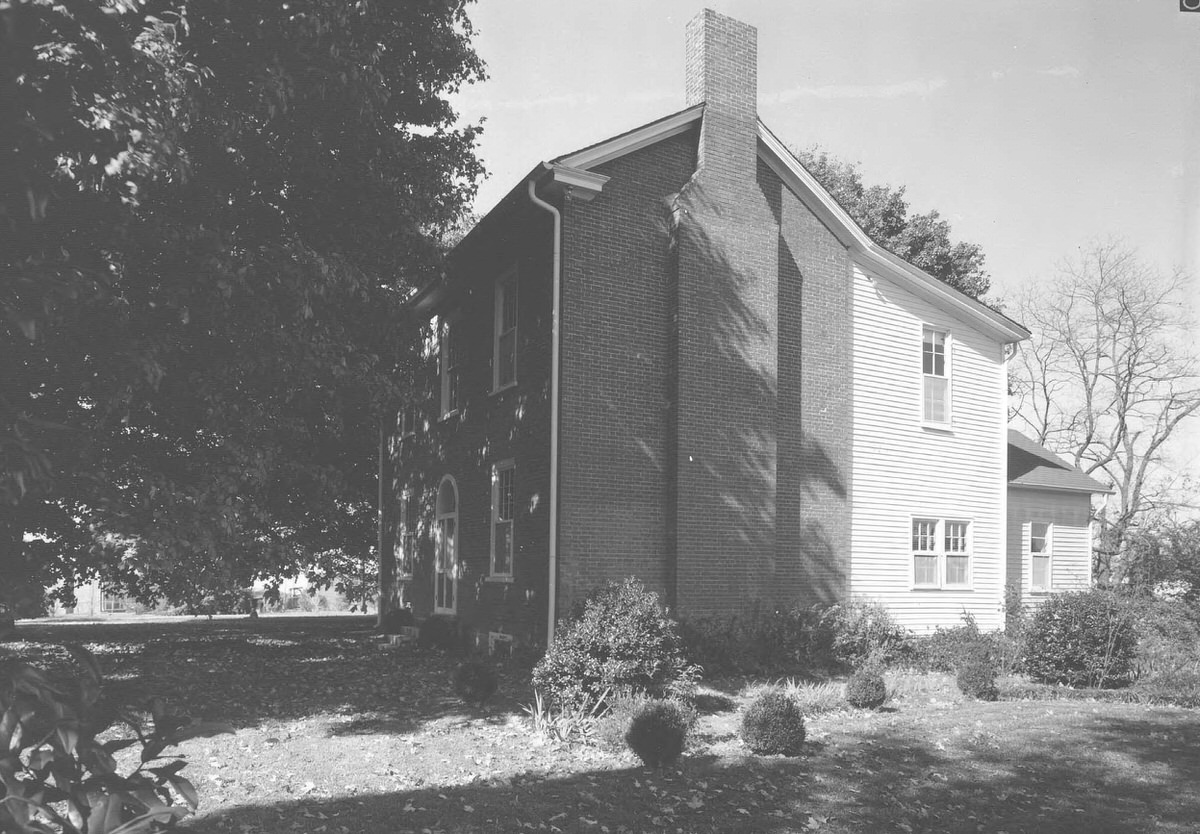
<box><xmin>553</xmin><ymin>104</ymin><xmax>1030</xmax><ymax>342</ymax></box>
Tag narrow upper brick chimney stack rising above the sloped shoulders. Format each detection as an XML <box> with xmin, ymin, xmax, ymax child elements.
<box><xmin>686</xmin><ymin>8</ymin><xmax>758</xmax><ymax>192</ymax></box>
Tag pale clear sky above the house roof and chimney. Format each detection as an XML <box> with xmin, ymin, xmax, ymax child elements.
<box><xmin>454</xmin><ymin>0</ymin><xmax>1200</xmax><ymax>489</ymax></box>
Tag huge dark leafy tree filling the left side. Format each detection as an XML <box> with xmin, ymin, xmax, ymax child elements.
<box><xmin>0</xmin><ymin>0</ymin><xmax>482</xmax><ymax>614</ymax></box>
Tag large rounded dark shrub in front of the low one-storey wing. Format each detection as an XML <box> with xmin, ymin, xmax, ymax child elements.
<box><xmin>1022</xmin><ymin>589</ymin><xmax>1138</xmax><ymax>688</ymax></box>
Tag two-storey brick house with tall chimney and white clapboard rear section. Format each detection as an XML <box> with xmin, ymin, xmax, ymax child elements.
<box><xmin>380</xmin><ymin>11</ymin><xmax>1028</xmax><ymax>644</ymax></box>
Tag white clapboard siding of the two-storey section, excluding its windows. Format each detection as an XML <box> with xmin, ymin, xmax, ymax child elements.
<box><xmin>850</xmin><ymin>264</ymin><xmax>1007</xmax><ymax>632</ymax></box>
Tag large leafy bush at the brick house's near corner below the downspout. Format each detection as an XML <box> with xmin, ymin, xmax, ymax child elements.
<box><xmin>533</xmin><ymin>578</ymin><xmax>700</xmax><ymax>706</ymax></box>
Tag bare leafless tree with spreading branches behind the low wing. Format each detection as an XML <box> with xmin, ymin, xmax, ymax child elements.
<box><xmin>1012</xmin><ymin>240</ymin><xmax>1200</xmax><ymax>576</ymax></box>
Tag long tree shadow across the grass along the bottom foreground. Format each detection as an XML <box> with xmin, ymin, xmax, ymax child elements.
<box><xmin>187</xmin><ymin>712</ymin><xmax>1200</xmax><ymax>834</ymax></box>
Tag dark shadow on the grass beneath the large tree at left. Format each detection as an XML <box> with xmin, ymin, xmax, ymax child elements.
<box><xmin>6</xmin><ymin>617</ymin><xmax>530</xmax><ymax>734</ymax></box>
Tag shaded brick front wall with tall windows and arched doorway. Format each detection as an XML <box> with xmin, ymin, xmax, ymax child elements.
<box><xmin>385</xmin><ymin>200</ymin><xmax>553</xmax><ymax>643</ymax></box>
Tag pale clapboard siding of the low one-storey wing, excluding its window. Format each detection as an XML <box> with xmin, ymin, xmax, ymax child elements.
<box><xmin>1008</xmin><ymin>487</ymin><xmax>1092</xmax><ymax>607</ymax></box>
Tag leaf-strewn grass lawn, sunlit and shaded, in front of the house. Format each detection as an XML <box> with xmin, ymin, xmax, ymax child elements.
<box><xmin>7</xmin><ymin>617</ymin><xmax>1200</xmax><ymax>834</ymax></box>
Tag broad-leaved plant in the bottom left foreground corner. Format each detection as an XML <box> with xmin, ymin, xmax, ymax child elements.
<box><xmin>0</xmin><ymin>646</ymin><xmax>218</xmax><ymax>834</ymax></box>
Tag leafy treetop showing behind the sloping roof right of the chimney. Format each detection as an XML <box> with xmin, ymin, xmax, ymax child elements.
<box><xmin>793</xmin><ymin>148</ymin><xmax>991</xmax><ymax>299</ymax></box>
